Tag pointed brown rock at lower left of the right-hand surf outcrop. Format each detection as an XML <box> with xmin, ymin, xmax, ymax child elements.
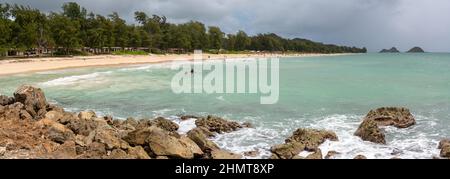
<box><xmin>355</xmin><ymin>119</ymin><xmax>386</xmax><ymax>144</ymax></box>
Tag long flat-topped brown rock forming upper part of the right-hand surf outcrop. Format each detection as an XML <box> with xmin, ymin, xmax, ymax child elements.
<box><xmin>364</xmin><ymin>107</ymin><xmax>416</xmax><ymax>128</ymax></box>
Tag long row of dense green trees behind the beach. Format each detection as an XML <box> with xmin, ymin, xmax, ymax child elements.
<box><xmin>0</xmin><ymin>2</ymin><xmax>366</xmax><ymax>54</ymax></box>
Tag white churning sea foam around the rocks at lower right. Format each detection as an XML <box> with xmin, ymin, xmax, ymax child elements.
<box><xmin>213</xmin><ymin>115</ymin><xmax>441</xmax><ymax>159</ymax></box>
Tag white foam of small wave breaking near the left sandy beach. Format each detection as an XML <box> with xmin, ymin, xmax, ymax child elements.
<box><xmin>40</xmin><ymin>71</ymin><xmax>112</xmax><ymax>87</ymax></box>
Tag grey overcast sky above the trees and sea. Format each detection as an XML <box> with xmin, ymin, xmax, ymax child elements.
<box><xmin>0</xmin><ymin>0</ymin><xmax>450</xmax><ymax>52</ymax></box>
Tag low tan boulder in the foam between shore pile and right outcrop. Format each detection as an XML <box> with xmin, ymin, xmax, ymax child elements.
<box><xmin>285</xmin><ymin>129</ymin><xmax>338</xmax><ymax>151</ymax></box>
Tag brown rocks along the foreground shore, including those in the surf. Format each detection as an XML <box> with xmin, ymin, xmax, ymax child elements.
<box><xmin>0</xmin><ymin>85</ymin><xmax>450</xmax><ymax>159</ymax></box>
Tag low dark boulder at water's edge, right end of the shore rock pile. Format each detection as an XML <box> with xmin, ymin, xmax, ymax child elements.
<box><xmin>195</xmin><ymin>115</ymin><xmax>242</xmax><ymax>133</ymax></box>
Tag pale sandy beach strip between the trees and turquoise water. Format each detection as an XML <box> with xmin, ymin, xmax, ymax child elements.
<box><xmin>0</xmin><ymin>54</ymin><xmax>345</xmax><ymax>76</ymax></box>
